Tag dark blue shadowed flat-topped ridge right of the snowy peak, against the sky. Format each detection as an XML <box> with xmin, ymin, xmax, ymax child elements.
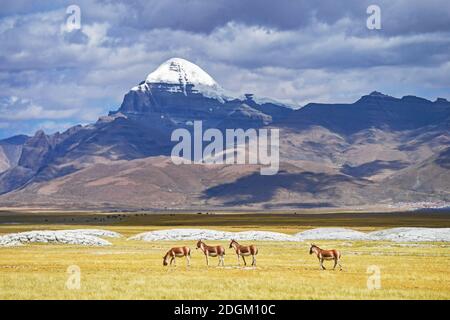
<box><xmin>280</xmin><ymin>91</ymin><xmax>450</xmax><ymax>135</ymax></box>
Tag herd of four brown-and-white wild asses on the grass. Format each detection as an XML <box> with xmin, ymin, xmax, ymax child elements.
<box><xmin>163</xmin><ymin>240</ymin><xmax>342</xmax><ymax>270</ymax></box>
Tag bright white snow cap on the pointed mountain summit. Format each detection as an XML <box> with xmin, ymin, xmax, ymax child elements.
<box><xmin>145</xmin><ymin>58</ymin><xmax>220</xmax><ymax>88</ymax></box>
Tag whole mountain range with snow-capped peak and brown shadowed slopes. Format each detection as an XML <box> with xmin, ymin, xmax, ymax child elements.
<box><xmin>0</xmin><ymin>58</ymin><xmax>450</xmax><ymax>210</ymax></box>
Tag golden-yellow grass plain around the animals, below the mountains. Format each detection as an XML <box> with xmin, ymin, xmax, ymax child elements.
<box><xmin>0</xmin><ymin>214</ymin><xmax>450</xmax><ymax>299</ymax></box>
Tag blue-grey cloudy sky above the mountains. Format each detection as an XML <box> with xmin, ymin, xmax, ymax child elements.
<box><xmin>0</xmin><ymin>0</ymin><xmax>450</xmax><ymax>138</ymax></box>
